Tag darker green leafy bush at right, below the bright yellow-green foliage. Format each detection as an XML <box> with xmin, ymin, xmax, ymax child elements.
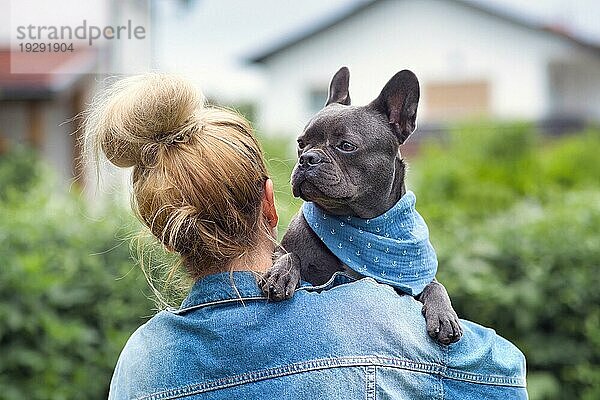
<box><xmin>430</xmin><ymin>190</ymin><xmax>600</xmax><ymax>399</ymax></box>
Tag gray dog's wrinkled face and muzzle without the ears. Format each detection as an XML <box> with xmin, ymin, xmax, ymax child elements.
<box><xmin>292</xmin><ymin>103</ymin><xmax>398</xmax><ymax>215</ymax></box>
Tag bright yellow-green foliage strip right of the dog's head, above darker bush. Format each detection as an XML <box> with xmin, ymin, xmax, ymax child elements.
<box><xmin>408</xmin><ymin>123</ymin><xmax>600</xmax><ymax>222</ymax></box>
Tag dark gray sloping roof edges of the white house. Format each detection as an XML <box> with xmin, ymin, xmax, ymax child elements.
<box><xmin>247</xmin><ymin>0</ymin><xmax>600</xmax><ymax>64</ymax></box>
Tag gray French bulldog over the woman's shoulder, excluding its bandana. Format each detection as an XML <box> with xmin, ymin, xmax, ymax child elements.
<box><xmin>261</xmin><ymin>67</ymin><xmax>462</xmax><ymax>344</ymax></box>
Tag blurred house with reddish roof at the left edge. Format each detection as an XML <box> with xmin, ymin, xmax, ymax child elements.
<box><xmin>0</xmin><ymin>49</ymin><xmax>97</xmax><ymax>183</ymax></box>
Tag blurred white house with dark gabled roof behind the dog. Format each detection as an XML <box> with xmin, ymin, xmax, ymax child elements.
<box><xmin>249</xmin><ymin>0</ymin><xmax>600</xmax><ymax>135</ymax></box>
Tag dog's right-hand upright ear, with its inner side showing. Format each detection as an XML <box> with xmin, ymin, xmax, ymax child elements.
<box><xmin>369</xmin><ymin>69</ymin><xmax>420</xmax><ymax>144</ymax></box>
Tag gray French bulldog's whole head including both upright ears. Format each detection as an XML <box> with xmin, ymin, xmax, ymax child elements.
<box><xmin>292</xmin><ymin>68</ymin><xmax>418</xmax><ymax>218</ymax></box>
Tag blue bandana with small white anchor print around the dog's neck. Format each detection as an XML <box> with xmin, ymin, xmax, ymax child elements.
<box><xmin>302</xmin><ymin>191</ymin><xmax>437</xmax><ymax>296</ymax></box>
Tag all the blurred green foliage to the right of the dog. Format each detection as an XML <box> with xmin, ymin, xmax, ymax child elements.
<box><xmin>409</xmin><ymin>124</ymin><xmax>600</xmax><ymax>399</ymax></box>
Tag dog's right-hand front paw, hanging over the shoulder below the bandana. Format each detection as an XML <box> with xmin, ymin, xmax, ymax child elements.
<box><xmin>417</xmin><ymin>279</ymin><xmax>462</xmax><ymax>344</ymax></box>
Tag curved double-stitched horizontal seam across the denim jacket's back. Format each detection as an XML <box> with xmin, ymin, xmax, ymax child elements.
<box><xmin>137</xmin><ymin>356</ymin><xmax>525</xmax><ymax>400</ymax></box>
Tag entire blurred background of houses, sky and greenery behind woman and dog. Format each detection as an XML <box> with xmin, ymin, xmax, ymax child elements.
<box><xmin>0</xmin><ymin>0</ymin><xmax>600</xmax><ymax>400</ymax></box>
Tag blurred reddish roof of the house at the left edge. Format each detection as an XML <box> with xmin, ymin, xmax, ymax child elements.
<box><xmin>0</xmin><ymin>49</ymin><xmax>97</xmax><ymax>101</ymax></box>
